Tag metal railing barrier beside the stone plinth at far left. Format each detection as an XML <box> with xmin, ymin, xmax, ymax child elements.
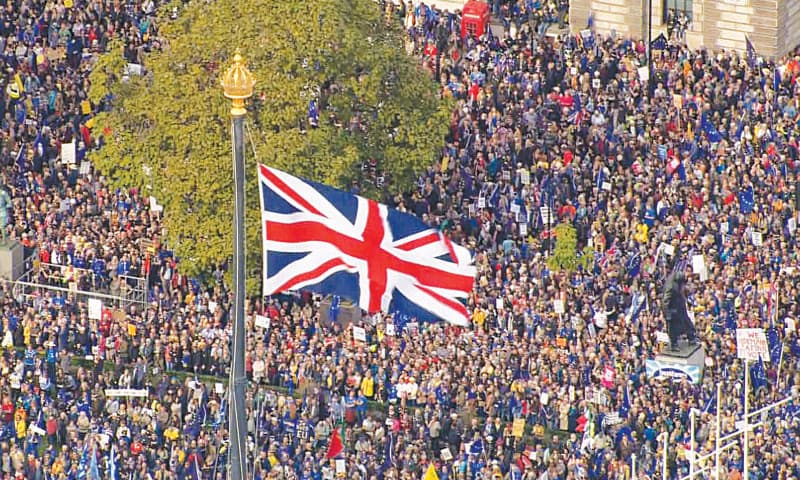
<box><xmin>6</xmin><ymin>253</ymin><xmax>148</xmax><ymax>309</ymax></box>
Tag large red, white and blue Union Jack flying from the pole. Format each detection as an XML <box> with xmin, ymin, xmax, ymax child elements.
<box><xmin>258</xmin><ymin>165</ymin><xmax>475</xmax><ymax>325</ymax></box>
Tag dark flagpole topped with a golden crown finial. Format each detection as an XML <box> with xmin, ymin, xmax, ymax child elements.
<box><xmin>220</xmin><ymin>50</ymin><xmax>256</xmax><ymax>480</ymax></box>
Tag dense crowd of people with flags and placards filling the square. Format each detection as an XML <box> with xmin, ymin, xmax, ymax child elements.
<box><xmin>0</xmin><ymin>0</ymin><xmax>800</xmax><ymax>480</ymax></box>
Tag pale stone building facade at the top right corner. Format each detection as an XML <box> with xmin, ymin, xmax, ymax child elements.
<box><xmin>570</xmin><ymin>0</ymin><xmax>800</xmax><ymax>59</ymax></box>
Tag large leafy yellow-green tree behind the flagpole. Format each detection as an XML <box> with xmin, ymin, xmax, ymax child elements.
<box><xmin>90</xmin><ymin>0</ymin><xmax>451</xmax><ymax>291</ymax></box>
